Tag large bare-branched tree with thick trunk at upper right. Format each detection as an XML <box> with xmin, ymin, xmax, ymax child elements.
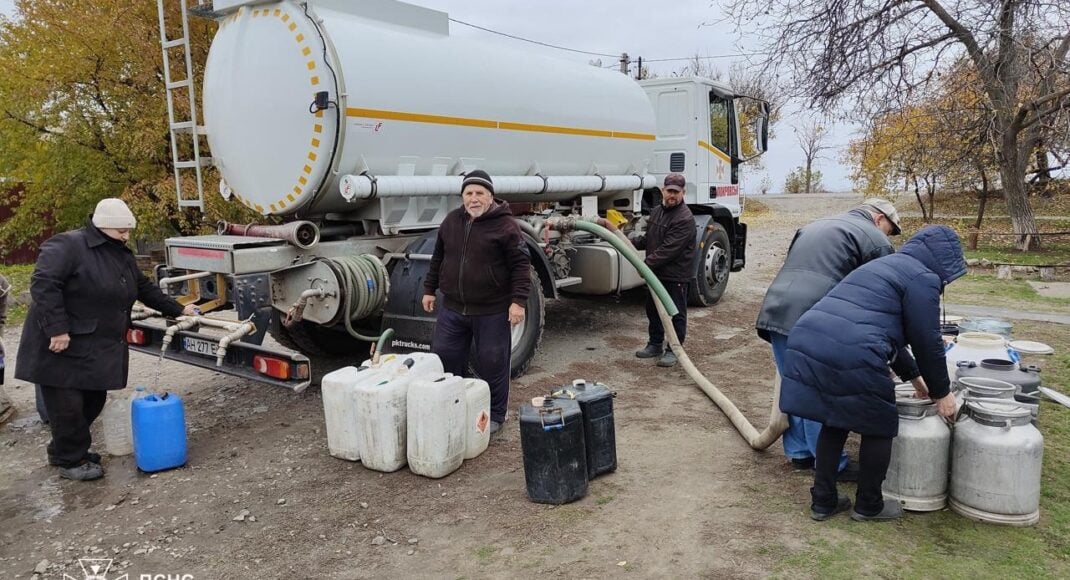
<box><xmin>728</xmin><ymin>0</ymin><xmax>1070</xmax><ymax>249</ymax></box>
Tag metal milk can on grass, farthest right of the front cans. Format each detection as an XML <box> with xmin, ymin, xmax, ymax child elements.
<box><xmin>948</xmin><ymin>400</ymin><xmax>1044</xmax><ymax>525</ymax></box>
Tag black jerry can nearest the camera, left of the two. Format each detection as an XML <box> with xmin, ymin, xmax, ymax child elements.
<box><xmin>520</xmin><ymin>397</ymin><xmax>587</xmax><ymax>504</ymax></box>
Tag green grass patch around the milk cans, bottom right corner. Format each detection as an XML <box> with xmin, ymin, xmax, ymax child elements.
<box><xmin>770</xmin><ymin>321</ymin><xmax>1070</xmax><ymax>579</ymax></box>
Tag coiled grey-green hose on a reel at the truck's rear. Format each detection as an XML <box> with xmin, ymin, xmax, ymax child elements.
<box><xmin>327</xmin><ymin>254</ymin><xmax>394</xmax><ymax>358</ymax></box>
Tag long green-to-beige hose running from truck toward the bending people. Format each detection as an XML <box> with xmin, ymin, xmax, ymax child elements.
<box><xmin>547</xmin><ymin>218</ymin><xmax>788</xmax><ymax>449</ymax></box>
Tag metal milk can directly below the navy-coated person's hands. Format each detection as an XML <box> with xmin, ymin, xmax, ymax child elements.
<box><xmin>882</xmin><ymin>388</ymin><xmax>951</xmax><ymax>512</ymax></box>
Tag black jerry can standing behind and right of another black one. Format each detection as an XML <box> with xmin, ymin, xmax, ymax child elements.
<box><xmin>553</xmin><ymin>379</ymin><xmax>616</xmax><ymax>479</ymax></box>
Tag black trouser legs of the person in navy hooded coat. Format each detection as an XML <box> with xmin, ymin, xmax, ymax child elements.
<box><xmin>810</xmin><ymin>425</ymin><xmax>892</xmax><ymax>516</ymax></box>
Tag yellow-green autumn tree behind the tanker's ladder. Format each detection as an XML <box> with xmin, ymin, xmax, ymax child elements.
<box><xmin>0</xmin><ymin>0</ymin><xmax>255</xmax><ymax>258</ymax></box>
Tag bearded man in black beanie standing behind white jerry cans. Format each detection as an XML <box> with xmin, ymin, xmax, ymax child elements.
<box><xmin>423</xmin><ymin>169</ymin><xmax>531</xmax><ymax>433</ymax></box>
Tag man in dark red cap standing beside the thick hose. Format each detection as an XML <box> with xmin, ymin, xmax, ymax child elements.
<box><xmin>632</xmin><ymin>173</ymin><xmax>694</xmax><ymax>367</ymax></box>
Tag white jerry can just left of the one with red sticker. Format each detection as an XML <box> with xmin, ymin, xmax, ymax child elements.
<box><xmin>408</xmin><ymin>375</ymin><xmax>467</xmax><ymax>477</ymax></box>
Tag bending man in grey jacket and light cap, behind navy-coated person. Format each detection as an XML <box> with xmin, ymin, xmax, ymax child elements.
<box><xmin>754</xmin><ymin>199</ymin><xmax>913</xmax><ymax>480</ymax></box>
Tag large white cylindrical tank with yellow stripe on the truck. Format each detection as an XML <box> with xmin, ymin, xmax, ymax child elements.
<box><xmin>203</xmin><ymin>0</ymin><xmax>656</xmax><ymax>217</ymax></box>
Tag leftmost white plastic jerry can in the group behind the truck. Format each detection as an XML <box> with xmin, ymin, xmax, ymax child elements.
<box><xmin>320</xmin><ymin>367</ymin><xmax>385</xmax><ymax>461</ymax></box>
